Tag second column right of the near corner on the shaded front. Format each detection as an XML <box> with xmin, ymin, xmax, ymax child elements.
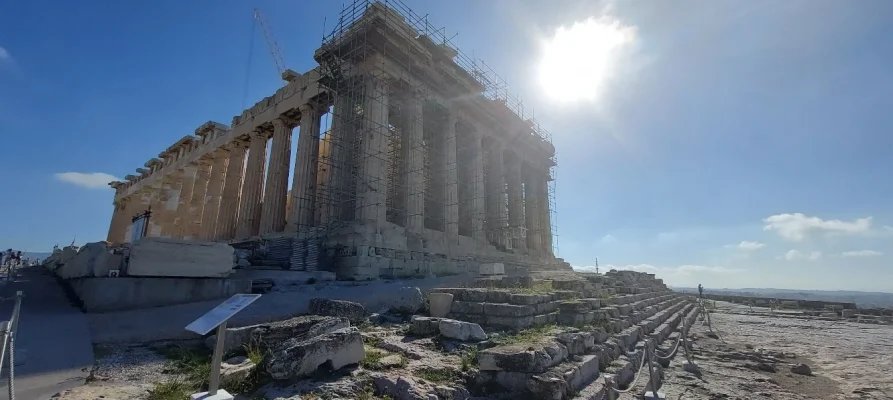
<box><xmin>400</xmin><ymin>93</ymin><xmax>425</xmax><ymax>233</ymax></box>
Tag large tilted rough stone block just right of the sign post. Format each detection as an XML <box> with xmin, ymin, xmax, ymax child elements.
<box><xmin>264</xmin><ymin>327</ymin><xmax>366</xmax><ymax>380</ymax></box>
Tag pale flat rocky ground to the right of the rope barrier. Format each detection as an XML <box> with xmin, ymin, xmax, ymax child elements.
<box><xmin>644</xmin><ymin>303</ymin><xmax>893</xmax><ymax>400</ymax></box>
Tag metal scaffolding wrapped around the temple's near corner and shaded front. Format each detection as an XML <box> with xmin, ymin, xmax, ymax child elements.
<box><xmin>292</xmin><ymin>0</ymin><xmax>556</xmax><ymax>269</ymax></box>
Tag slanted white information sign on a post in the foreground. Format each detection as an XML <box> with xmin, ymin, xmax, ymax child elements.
<box><xmin>186</xmin><ymin>294</ymin><xmax>260</xmax><ymax>400</ymax></box>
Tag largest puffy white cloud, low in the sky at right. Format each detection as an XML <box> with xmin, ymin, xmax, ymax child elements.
<box><xmin>763</xmin><ymin>213</ymin><xmax>872</xmax><ymax>242</ymax></box>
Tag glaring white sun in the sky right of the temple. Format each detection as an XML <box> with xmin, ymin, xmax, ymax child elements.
<box><xmin>539</xmin><ymin>17</ymin><xmax>636</xmax><ymax>101</ymax></box>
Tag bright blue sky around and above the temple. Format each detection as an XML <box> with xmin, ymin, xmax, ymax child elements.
<box><xmin>0</xmin><ymin>0</ymin><xmax>893</xmax><ymax>291</ymax></box>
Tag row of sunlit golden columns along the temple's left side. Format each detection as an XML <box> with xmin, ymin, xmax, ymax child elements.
<box><xmin>108</xmin><ymin>105</ymin><xmax>321</xmax><ymax>241</ymax></box>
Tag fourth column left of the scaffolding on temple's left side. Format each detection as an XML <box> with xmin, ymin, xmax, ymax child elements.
<box><xmin>214</xmin><ymin>139</ymin><xmax>248</xmax><ymax>240</ymax></box>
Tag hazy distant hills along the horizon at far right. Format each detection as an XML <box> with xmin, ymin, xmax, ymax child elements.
<box><xmin>672</xmin><ymin>287</ymin><xmax>893</xmax><ymax>308</ymax></box>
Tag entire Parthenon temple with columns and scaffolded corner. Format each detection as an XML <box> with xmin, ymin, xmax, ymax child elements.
<box><xmin>108</xmin><ymin>0</ymin><xmax>567</xmax><ymax>279</ymax></box>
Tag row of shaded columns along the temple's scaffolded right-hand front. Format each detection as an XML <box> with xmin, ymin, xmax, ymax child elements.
<box><xmin>313</xmin><ymin>78</ymin><xmax>551</xmax><ymax>253</ymax></box>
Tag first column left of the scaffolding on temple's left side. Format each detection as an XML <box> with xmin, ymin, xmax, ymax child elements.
<box><xmin>286</xmin><ymin>104</ymin><xmax>323</xmax><ymax>232</ymax></box>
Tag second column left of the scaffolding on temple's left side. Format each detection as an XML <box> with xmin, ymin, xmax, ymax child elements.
<box><xmin>259</xmin><ymin>118</ymin><xmax>294</xmax><ymax>235</ymax></box>
